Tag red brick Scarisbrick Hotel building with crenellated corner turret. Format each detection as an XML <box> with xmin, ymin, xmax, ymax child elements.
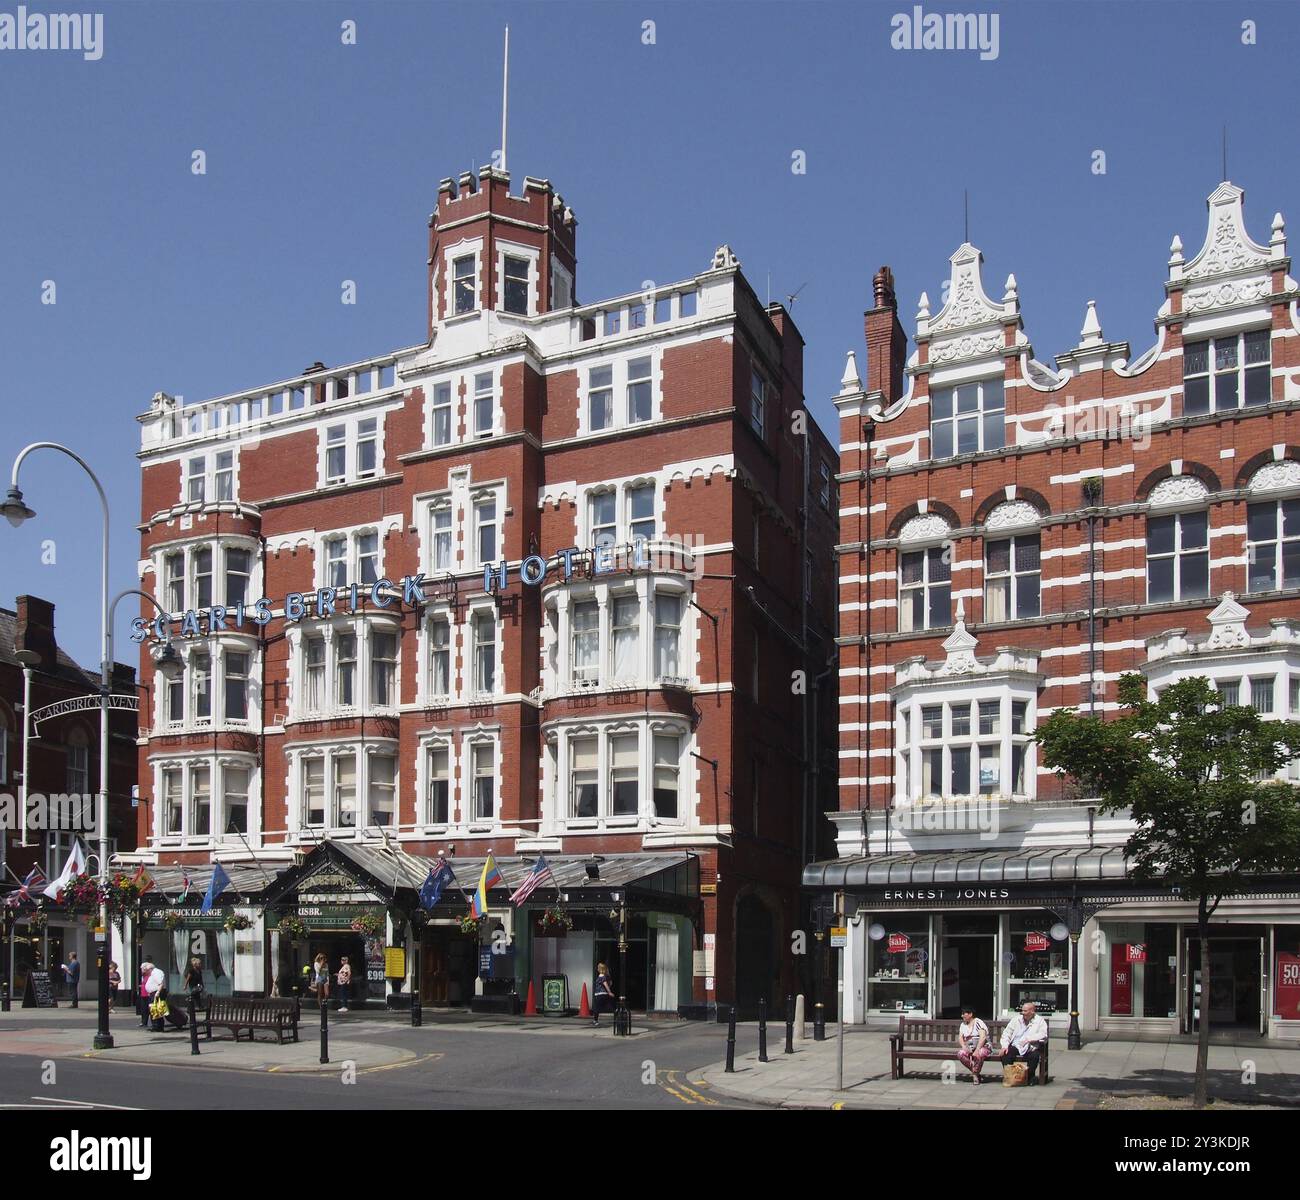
<box><xmin>129</xmin><ymin>168</ymin><xmax>836</xmax><ymax>1010</ymax></box>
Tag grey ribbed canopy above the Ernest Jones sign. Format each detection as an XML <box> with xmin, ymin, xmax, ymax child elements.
<box><xmin>803</xmin><ymin>846</ymin><xmax>1128</xmax><ymax>892</ymax></box>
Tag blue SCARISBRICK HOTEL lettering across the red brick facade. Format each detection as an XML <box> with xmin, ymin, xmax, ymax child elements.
<box><xmin>131</xmin><ymin>538</ymin><xmax>670</xmax><ymax>642</ymax></box>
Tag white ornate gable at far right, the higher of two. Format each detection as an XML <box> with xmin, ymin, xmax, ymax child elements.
<box><xmin>1169</xmin><ymin>181</ymin><xmax>1286</xmax><ymax>313</ymax></box>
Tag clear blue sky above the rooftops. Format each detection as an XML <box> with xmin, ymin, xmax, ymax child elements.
<box><xmin>0</xmin><ymin>0</ymin><xmax>1300</xmax><ymax>663</ymax></box>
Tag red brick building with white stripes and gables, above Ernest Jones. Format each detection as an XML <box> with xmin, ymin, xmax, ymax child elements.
<box><xmin>805</xmin><ymin>183</ymin><xmax>1300</xmax><ymax>1037</ymax></box>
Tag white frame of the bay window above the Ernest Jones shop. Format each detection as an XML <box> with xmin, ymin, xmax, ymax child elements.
<box><xmin>894</xmin><ymin>675</ymin><xmax>1037</xmax><ymax>803</ymax></box>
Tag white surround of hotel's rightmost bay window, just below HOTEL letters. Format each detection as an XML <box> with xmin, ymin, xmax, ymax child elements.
<box><xmin>542</xmin><ymin>572</ymin><xmax>698</xmax><ymax>696</ymax></box>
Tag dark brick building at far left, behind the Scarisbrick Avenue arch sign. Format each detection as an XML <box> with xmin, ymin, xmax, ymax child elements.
<box><xmin>0</xmin><ymin>595</ymin><xmax>137</xmax><ymax>1002</ymax></box>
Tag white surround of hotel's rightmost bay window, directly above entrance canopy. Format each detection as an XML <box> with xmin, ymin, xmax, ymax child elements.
<box><xmin>541</xmin><ymin>715</ymin><xmax>696</xmax><ymax>836</ymax></box>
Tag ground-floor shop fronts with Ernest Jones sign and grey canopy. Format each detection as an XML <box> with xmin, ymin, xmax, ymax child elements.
<box><xmin>803</xmin><ymin>848</ymin><xmax>1300</xmax><ymax>1040</ymax></box>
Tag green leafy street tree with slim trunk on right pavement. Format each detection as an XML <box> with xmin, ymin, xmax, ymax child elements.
<box><xmin>1035</xmin><ymin>675</ymin><xmax>1300</xmax><ymax>1108</ymax></box>
